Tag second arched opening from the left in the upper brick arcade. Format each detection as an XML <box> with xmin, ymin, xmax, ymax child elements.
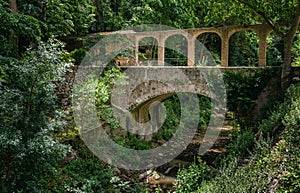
<box><xmin>164</xmin><ymin>34</ymin><xmax>188</xmax><ymax>66</ymax></box>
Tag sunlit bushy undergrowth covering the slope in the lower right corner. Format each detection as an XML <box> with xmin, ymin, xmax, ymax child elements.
<box><xmin>179</xmin><ymin>84</ymin><xmax>300</xmax><ymax>193</ymax></box>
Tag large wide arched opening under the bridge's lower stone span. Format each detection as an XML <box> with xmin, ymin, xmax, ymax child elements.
<box><xmin>133</xmin><ymin>92</ymin><xmax>212</xmax><ymax>146</ymax></box>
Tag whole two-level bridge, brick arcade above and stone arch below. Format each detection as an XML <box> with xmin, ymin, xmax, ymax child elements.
<box><xmin>73</xmin><ymin>24</ymin><xmax>288</xmax><ymax>130</ymax></box>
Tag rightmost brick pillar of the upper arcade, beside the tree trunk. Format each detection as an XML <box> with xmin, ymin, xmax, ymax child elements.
<box><xmin>258</xmin><ymin>31</ymin><xmax>269</xmax><ymax>67</ymax></box>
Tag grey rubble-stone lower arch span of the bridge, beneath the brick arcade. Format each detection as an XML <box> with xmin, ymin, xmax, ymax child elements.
<box><xmin>112</xmin><ymin>66</ymin><xmax>213</xmax><ymax>122</ymax></box>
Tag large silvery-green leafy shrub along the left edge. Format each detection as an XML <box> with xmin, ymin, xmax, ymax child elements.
<box><xmin>0</xmin><ymin>40</ymin><xmax>72</xmax><ymax>192</ymax></box>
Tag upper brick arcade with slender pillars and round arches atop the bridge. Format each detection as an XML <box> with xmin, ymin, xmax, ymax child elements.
<box><xmin>100</xmin><ymin>24</ymin><xmax>272</xmax><ymax>67</ymax></box>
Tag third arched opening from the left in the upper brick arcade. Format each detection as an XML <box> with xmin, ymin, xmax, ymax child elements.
<box><xmin>195</xmin><ymin>32</ymin><xmax>221</xmax><ymax>66</ymax></box>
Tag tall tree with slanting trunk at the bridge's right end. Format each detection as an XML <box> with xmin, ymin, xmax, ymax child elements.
<box><xmin>235</xmin><ymin>0</ymin><xmax>300</xmax><ymax>91</ymax></box>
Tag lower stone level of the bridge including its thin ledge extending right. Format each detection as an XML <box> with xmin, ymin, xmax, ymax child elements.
<box><xmin>111</xmin><ymin>66</ymin><xmax>280</xmax><ymax>126</ymax></box>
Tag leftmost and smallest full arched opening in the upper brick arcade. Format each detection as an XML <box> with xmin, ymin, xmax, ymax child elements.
<box><xmin>139</xmin><ymin>37</ymin><xmax>158</xmax><ymax>66</ymax></box>
